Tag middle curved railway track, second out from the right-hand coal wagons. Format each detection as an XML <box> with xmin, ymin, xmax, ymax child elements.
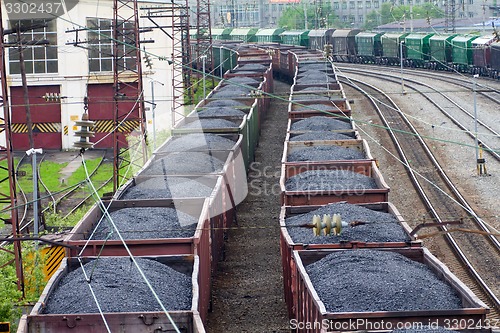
<box><xmin>336</xmin><ymin>68</ymin><xmax>500</xmax><ymax>162</ymax></box>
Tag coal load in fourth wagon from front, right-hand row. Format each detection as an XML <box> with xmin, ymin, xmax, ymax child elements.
<box><xmin>287</xmin><ymin>145</ymin><xmax>366</xmax><ymax>162</ymax></box>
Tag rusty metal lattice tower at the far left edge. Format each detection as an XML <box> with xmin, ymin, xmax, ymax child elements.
<box><xmin>0</xmin><ymin>6</ymin><xmax>24</xmax><ymax>292</ymax></box>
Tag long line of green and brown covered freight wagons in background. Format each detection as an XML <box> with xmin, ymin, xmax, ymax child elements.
<box><xmin>208</xmin><ymin>28</ymin><xmax>500</xmax><ymax>79</ymax></box>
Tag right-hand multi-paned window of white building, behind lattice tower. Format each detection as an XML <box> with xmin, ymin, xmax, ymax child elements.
<box><xmin>87</xmin><ymin>18</ymin><xmax>136</xmax><ymax>72</ymax></box>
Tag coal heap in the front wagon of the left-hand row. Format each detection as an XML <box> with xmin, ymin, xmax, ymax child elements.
<box><xmin>43</xmin><ymin>257</ymin><xmax>192</xmax><ymax>314</ymax></box>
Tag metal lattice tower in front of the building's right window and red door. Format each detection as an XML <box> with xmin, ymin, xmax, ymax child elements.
<box><xmin>113</xmin><ymin>0</ymin><xmax>147</xmax><ymax>191</ymax></box>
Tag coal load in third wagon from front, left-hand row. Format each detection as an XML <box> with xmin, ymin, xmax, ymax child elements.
<box><xmin>120</xmin><ymin>177</ymin><xmax>213</xmax><ymax>200</ymax></box>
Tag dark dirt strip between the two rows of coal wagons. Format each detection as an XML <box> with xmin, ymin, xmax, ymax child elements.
<box><xmin>207</xmin><ymin>81</ymin><xmax>290</xmax><ymax>333</ymax></box>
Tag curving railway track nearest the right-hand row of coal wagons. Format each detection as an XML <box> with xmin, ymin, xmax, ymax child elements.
<box><xmin>340</xmin><ymin>78</ymin><xmax>500</xmax><ymax>320</ymax></box>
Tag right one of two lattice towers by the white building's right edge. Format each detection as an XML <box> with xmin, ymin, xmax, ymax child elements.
<box><xmin>194</xmin><ymin>0</ymin><xmax>214</xmax><ymax>88</ymax></box>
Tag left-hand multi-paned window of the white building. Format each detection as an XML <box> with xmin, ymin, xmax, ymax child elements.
<box><xmin>8</xmin><ymin>20</ymin><xmax>58</xmax><ymax>74</ymax></box>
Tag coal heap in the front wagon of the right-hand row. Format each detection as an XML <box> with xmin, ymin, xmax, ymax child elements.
<box><xmin>306</xmin><ymin>250</ymin><xmax>462</xmax><ymax>312</ymax></box>
